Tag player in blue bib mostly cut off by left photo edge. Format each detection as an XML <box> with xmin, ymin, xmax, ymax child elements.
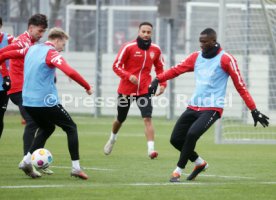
<box><xmin>0</xmin><ymin>17</ymin><xmax>14</xmax><ymax>138</ymax></box>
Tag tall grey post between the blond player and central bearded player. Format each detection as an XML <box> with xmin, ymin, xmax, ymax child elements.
<box><xmin>94</xmin><ymin>0</ymin><xmax>102</xmax><ymax>118</ymax></box>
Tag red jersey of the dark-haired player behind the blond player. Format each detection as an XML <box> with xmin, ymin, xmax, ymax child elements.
<box><xmin>0</xmin><ymin>31</ymin><xmax>35</xmax><ymax>94</ymax></box>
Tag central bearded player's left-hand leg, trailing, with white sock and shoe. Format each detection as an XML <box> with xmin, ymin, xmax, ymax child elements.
<box><xmin>104</xmin><ymin>94</ymin><xmax>133</xmax><ymax>155</ymax></box>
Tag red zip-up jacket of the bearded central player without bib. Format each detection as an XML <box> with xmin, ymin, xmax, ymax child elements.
<box><xmin>113</xmin><ymin>40</ymin><xmax>167</xmax><ymax>96</ymax></box>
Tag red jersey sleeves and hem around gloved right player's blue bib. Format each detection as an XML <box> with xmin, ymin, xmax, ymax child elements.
<box><xmin>157</xmin><ymin>49</ymin><xmax>256</xmax><ymax>114</ymax></box>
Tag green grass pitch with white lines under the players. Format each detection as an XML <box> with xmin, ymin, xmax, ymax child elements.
<box><xmin>0</xmin><ymin>113</ymin><xmax>276</xmax><ymax>200</ymax></box>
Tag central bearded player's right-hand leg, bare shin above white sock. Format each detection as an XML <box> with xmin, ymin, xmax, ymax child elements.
<box><xmin>136</xmin><ymin>94</ymin><xmax>158</xmax><ymax>159</ymax></box>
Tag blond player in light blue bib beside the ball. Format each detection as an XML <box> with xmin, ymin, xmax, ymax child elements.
<box><xmin>0</xmin><ymin>28</ymin><xmax>92</xmax><ymax>180</ymax></box>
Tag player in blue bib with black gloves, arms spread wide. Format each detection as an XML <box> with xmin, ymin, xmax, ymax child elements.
<box><xmin>149</xmin><ymin>28</ymin><xmax>269</xmax><ymax>182</ymax></box>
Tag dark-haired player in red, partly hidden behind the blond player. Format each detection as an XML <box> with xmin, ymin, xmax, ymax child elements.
<box><xmin>0</xmin><ymin>14</ymin><xmax>49</xmax><ymax>175</ymax></box>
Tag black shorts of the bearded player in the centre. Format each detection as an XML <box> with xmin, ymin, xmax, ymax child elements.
<box><xmin>117</xmin><ymin>94</ymin><xmax>152</xmax><ymax>123</ymax></box>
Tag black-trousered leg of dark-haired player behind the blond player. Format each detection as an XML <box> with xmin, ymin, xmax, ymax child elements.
<box><xmin>10</xmin><ymin>92</ymin><xmax>38</xmax><ymax>155</ymax></box>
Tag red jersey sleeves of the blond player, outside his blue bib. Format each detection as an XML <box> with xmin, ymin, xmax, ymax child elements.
<box><xmin>0</xmin><ymin>41</ymin><xmax>91</xmax><ymax>90</ymax></box>
